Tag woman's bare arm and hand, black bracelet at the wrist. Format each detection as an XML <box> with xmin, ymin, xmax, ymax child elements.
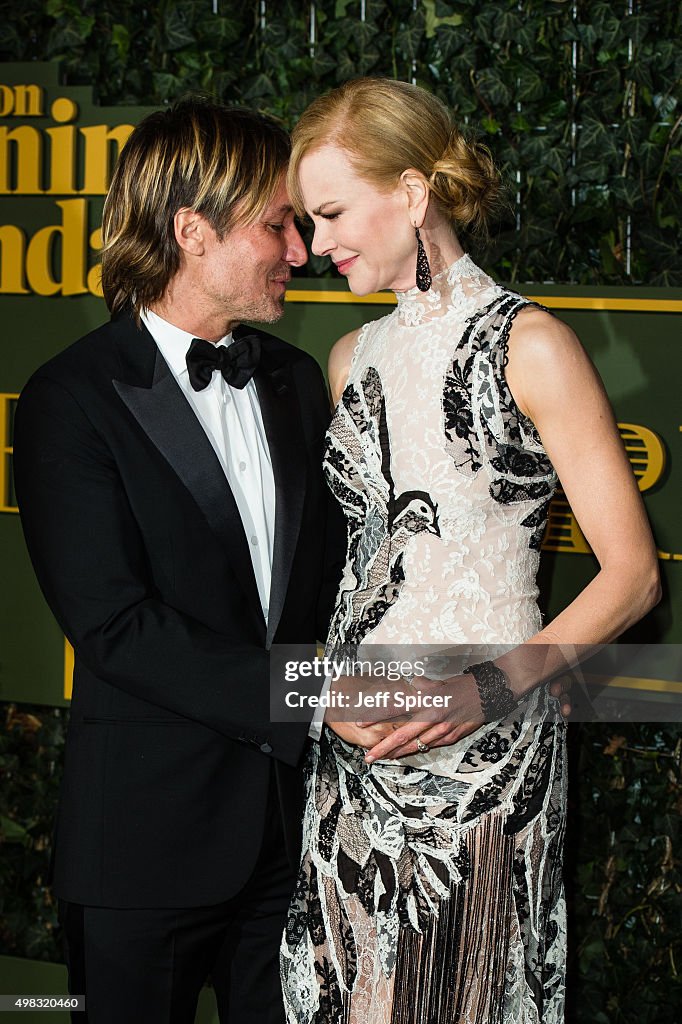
<box><xmin>370</xmin><ymin>309</ymin><xmax>660</xmax><ymax>759</ymax></box>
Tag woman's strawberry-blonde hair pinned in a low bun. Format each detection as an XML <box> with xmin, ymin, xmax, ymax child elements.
<box><xmin>287</xmin><ymin>78</ymin><xmax>501</xmax><ymax>231</ymax></box>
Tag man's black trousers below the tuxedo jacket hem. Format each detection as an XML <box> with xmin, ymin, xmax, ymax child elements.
<box><xmin>59</xmin><ymin>778</ymin><xmax>295</xmax><ymax>1024</ymax></box>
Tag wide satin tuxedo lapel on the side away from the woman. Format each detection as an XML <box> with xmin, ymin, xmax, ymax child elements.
<box><xmin>113</xmin><ymin>321</ymin><xmax>261</xmax><ymax>622</ymax></box>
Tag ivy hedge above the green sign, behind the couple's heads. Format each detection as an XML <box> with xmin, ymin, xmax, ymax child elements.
<box><xmin>0</xmin><ymin>0</ymin><xmax>682</xmax><ymax>286</ymax></box>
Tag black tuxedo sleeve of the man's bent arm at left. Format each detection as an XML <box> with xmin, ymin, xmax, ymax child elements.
<box><xmin>14</xmin><ymin>376</ymin><xmax>306</xmax><ymax>764</ymax></box>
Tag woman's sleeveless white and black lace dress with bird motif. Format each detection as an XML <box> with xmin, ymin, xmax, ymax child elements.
<box><xmin>281</xmin><ymin>256</ymin><xmax>566</xmax><ymax>1024</ymax></box>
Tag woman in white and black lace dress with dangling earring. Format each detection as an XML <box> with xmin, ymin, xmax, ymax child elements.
<box><xmin>282</xmin><ymin>79</ymin><xmax>659</xmax><ymax>1024</ymax></box>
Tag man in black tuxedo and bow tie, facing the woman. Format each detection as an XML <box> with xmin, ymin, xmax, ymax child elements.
<box><xmin>14</xmin><ymin>100</ymin><xmax>343</xmax><ymax>1024</ymax></box>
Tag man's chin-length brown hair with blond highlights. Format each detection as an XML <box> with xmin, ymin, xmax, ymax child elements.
<box><xmin>101</xmin><ymin>98</ymin><xmax>290</xmax><ymax>314</ymax></box>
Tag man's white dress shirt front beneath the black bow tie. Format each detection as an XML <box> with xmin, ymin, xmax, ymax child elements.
<box><xmin>142</xmin><ymin>309</ymin><xmax>274</xmax><ymax>623</ymax></box>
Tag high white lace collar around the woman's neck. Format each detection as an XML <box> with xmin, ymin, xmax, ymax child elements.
<box><xmin>395</xmin><ymin>253</ymin><xmax>497</xmax><ymax>327</ymax></box>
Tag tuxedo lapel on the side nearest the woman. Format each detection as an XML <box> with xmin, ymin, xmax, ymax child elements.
<box><xmin>254</xmin><ymin>342</ymin><xmax>306</xmax><ymax>647</ymax></box>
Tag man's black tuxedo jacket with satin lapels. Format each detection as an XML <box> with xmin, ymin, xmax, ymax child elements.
<box><xmin>14</xmin><ymin>314</ymin><xmax>343</xmax><ymax>907</ymax></box>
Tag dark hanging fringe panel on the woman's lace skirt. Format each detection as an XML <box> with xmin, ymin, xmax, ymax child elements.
<box><xmin>390</xmin><ymin>814</ymin><xmax>514</xmax><ymax>1024</ymax></box>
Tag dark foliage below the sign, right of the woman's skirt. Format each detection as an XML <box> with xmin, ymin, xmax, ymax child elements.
<box><xmin>567</xmin><ymin>724</ymin><xmax>682</xmax><ymax>1024</ymax></box>
